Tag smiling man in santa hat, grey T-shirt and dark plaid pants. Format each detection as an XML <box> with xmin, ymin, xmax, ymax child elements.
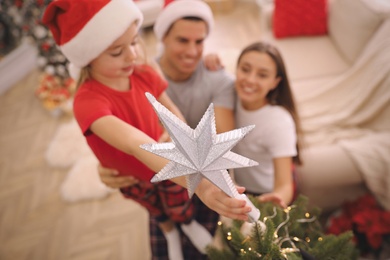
<box><xmin>99</xmin><ymin>0</ymin><xmax>234</xmax><ymax>260</ymax></box>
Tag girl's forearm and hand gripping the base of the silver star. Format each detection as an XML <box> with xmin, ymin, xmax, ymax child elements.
<box><xmin>196</xmin><ymin>179</ymin><xmax>251</xmax><ymax>221</ymax></box>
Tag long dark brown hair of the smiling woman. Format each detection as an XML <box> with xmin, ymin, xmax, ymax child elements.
<box><xmin>237</xmin><ymin>42</ymin><xmax>302</xmax><ymax>164</ymax></box>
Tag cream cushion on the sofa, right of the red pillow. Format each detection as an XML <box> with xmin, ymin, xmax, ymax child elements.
<box><xmin>328</xmin><ymin>0</ymin><xmax>383</xmax><ymax>64</ymax></box>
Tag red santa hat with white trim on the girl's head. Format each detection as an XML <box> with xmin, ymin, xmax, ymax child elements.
<box><xmin>42</xmin><ymin>0</ymin><xmax>143</xmax><ymax>79</ymax></box>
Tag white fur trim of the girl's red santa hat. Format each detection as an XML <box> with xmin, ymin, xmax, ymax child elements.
<box><xmin>60</xmin><ymin>0</ymin><xmax>143</xmax><ymax>68</ymax></box>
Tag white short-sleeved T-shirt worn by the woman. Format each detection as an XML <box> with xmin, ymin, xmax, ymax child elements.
<box><xmin>233</xmin><ymin>101</ymin><xmax>297</xmax><ymax>193</ymax></box>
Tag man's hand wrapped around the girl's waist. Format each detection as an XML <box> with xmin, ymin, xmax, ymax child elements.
<box><xmin>98</xmin><ymin>163</ymin><xmax>138</xmax><ymax>189</ymax></box>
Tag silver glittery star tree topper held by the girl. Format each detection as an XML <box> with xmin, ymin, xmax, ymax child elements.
<box><xmin>141</xmin><ymin>93</ymin><xmax>260</xmax><ymax>222</ymax></box>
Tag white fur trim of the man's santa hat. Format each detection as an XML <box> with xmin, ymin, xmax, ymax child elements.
<box><xmin>153</xmin><ymin>0</ymin><xmax>214</xmax><ymax>41</ymax></box>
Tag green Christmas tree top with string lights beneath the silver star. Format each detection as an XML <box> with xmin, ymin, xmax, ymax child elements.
<box><xmin>207</xmin><ymin>196</ymin><xmax>359</xmax><ymax>260</ymax></box>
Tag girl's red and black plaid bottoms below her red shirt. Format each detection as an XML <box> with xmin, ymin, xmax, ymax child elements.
<box><xmin>121</xmin><ymin>181</ymin><xmax>194</xmax><ymax>223</ymax></box>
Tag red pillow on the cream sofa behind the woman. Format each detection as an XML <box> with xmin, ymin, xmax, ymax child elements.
<box><xmin>273</xmin><ymin>0</ymin><xmax>328</xmax><ymax>38</ymax></box>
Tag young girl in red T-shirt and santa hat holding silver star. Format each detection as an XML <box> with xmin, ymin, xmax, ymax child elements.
<box><xmin>43</xmin><ymin>0</ymin><xmax>248</xmax><ymax>259</ymax></box>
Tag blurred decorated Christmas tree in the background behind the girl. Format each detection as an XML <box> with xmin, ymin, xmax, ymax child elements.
<box><xmin>0</xmin><ymin>0</ymin><xmax>75</xmax><ymax>115</ymax></box>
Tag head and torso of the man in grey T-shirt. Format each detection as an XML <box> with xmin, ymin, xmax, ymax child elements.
<box><xmin>154</xmin><ymin>0</ymin><xmax>234</xmax><ymax>132</ymax></box>
